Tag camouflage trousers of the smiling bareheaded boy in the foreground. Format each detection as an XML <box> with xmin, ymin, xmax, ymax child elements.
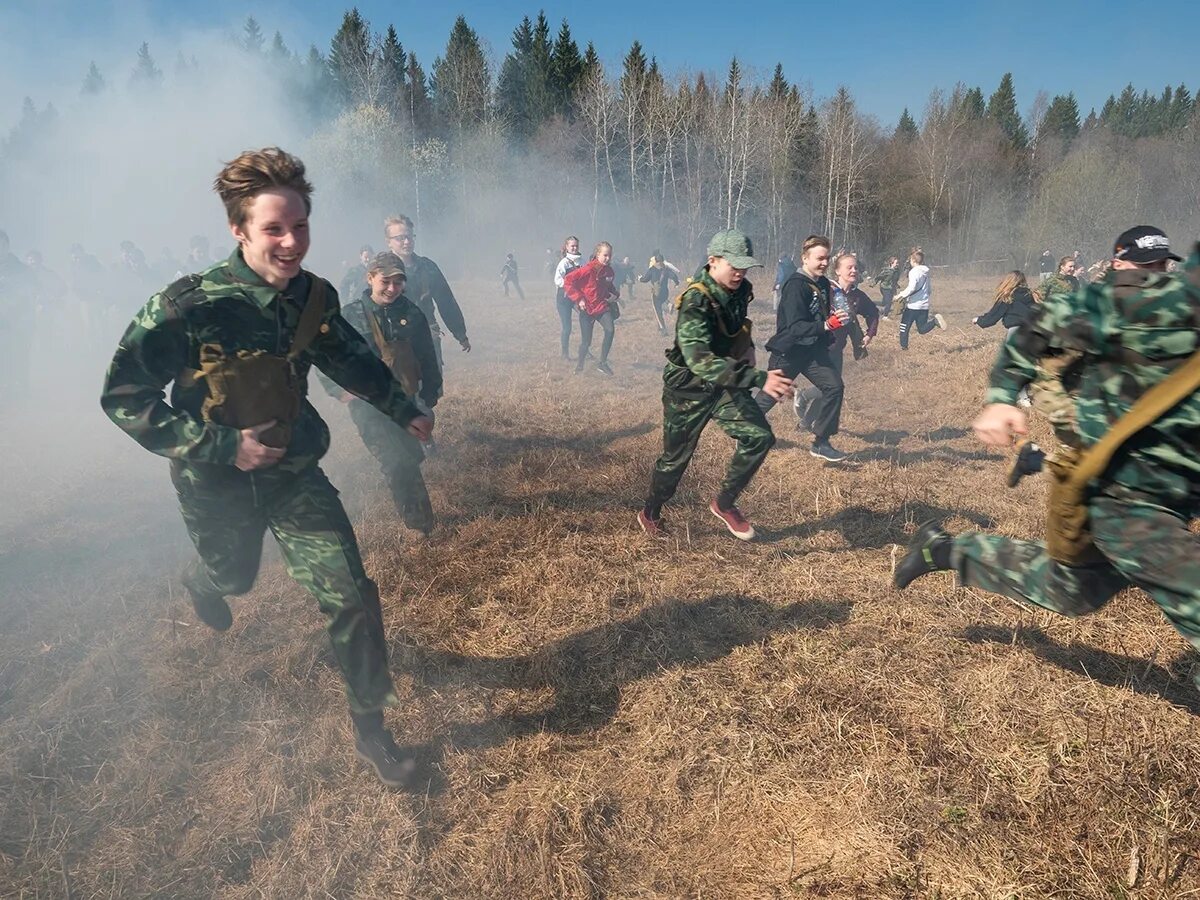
<box><xmin>170</xmin><ymin>461</ymin><xmax>396</xmax><ymax>713</ymax></box>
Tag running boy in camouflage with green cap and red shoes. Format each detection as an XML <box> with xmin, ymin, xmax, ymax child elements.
<box><xmin>637</xmin><ymin>229</ymin><xmax>792</xmax><ymax>540</ymax></box>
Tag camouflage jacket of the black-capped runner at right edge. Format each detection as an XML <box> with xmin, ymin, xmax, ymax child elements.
<box><xmin>986</xmin><ymin>245</ymin><xmax>1200</xmax><ymax>508</ymax></box>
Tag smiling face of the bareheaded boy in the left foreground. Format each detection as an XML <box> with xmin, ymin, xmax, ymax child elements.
<box><xmin>229</xmin><ymin>187</ymin><xmax>308</xmax><ymax>289</ymax></box>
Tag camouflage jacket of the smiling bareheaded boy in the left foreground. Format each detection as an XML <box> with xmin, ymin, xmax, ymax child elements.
<box><xmin>100</xmin><ymin>243</ymin><xmax>420</xmax><ymax>473</ymax></box>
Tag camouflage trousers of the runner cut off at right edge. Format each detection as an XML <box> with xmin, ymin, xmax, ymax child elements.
<box><xmin>950</xmin><ymin>485</ymin><xmax>1200</xmax><ymax>650</ymax></box>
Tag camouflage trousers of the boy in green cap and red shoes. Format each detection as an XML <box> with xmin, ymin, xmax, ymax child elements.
<box><xmin>646</xmin><ymin>388</ymin><xmax>775</xmax><ymax>510</ymax></box>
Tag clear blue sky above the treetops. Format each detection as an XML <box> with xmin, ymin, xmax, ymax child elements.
<box><xmin>0</xmin><ymin>0</ymin><xmax>1200</xmax><ymax>126</ymax></box>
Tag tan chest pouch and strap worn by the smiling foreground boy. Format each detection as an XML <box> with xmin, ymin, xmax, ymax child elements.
<box><xmin>176</xmin><ymin>276</ymin><xmax>325</xmax><ymax>449</ymax></box>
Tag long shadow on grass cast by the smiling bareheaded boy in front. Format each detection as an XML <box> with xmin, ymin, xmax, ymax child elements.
<box><xmin>395</xmin><ymin>596</ymin><xmax>852</xmax><ymax>768</ymax></box>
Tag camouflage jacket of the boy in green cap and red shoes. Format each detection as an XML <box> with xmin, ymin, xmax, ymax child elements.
<box><xmin>662</xmin><ymin>266</ymin><xmax>767</xmax><ymax>391</ymax></box>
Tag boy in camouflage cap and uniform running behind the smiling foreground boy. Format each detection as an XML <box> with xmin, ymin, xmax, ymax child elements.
<box><xmin>322</xmin><ymin>251</ymin><xmax>442</xmax><ymax>536</ymax></box>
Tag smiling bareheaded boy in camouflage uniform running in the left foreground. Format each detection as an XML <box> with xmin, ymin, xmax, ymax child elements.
<box><xmin>101</xmin><ymin>148</ymin><xmax>432</xmax><ymax>786</ymax></box>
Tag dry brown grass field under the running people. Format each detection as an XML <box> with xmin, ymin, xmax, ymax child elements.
<box><xmin>0</xmin><ymin>274</ymin><xmax>1200</xmax><ymax>900</ymax></box>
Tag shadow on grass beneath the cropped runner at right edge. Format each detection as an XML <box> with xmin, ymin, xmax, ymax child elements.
<box><xmin>960</xmin><ymin>625</ymin><xmax>1200</xmax><ymax>715</ymax></box>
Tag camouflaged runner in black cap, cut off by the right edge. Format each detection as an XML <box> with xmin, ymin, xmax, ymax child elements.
<box><xmin>895</xmin><ymin>226</ymin><xmax>1200</xmax><ymax>686</ymax></box>
